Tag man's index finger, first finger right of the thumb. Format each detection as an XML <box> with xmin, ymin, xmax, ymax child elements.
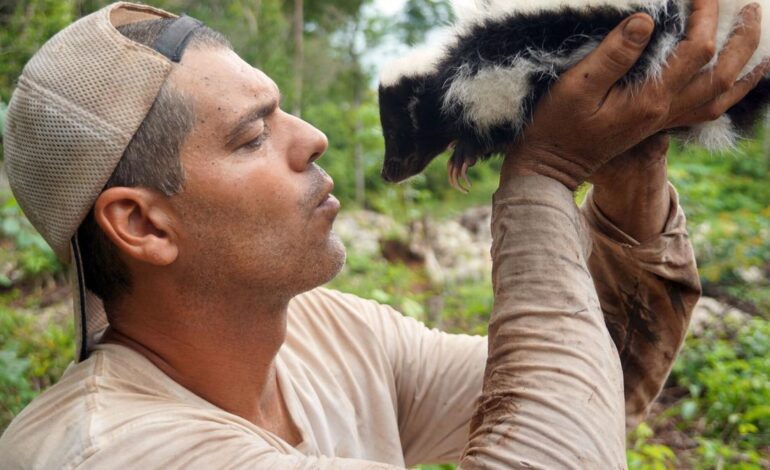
<box><xmin>663</xmin><ymin>0</ymin><xmax>719</xmax><ymax>88</ymax></box>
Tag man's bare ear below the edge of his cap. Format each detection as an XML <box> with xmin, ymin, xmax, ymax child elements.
<box><xmin>94</xmin><ymin>187</ymin><xmax>179</xmax><ymax>266</ymax></box>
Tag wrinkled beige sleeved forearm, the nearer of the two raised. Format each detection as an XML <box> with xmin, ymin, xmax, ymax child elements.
<box><xmin>462</xmin><ymin>176</ymin><xmax>625</xmax><ymax>468</ymax></box>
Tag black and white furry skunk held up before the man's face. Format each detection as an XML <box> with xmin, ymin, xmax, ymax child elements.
<box><xmin>379</xmin><ymin>0</ymin><xmax>770</xmax><ymax>190</ymax></box>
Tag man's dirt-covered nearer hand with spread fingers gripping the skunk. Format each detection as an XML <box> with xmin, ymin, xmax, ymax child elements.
<box><xmin>501</xmin><ymin>0</ymin><xmax>768</xmax><ymax>189</ymax></box>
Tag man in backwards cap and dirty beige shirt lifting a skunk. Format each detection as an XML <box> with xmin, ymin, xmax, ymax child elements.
<box><xmin>0</xmin><ymin>0</ymin><xmax>767</xmax><ymax>468</ymax></box>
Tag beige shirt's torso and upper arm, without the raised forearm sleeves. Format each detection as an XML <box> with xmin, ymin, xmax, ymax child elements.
<box><xmin>0</xmin><ymin>288</ymin><xmax>486</xmax><ymax>469</ymax></box>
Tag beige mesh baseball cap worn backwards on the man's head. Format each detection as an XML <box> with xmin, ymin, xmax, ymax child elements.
<box><xmin>4</xmin><ymin>2</ymin><xmax>202</xmax><ymax>362</ymax></box>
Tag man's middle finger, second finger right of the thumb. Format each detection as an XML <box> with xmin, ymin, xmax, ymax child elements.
<box><xmin>672</xmin><ymin>4</ymin><xmax>762</xmax><ymax>116</ymax></box>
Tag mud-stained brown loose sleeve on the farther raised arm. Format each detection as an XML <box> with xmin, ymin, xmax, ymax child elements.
<box><xmin>581</xmin><ymin>185</ymin><xmax>701</xmax><ymax>426</ymax></box>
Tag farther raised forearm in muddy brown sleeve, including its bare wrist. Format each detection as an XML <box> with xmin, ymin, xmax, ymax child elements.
<box><xmin>582</xmin><ymin>134</ymin><xmax>700</xmax><ymax>426</ymax></box>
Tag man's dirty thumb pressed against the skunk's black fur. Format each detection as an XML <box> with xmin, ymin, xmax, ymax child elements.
<box><xmin>564</xmin><ymin>13</ymin><xmax>655</xmax><ymax>100</ymax></box>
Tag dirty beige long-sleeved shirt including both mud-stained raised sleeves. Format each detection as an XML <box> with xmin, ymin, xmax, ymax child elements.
<box><xmin>0</xmin><ymin>176</ymin><xmax>699</xmax><ymax>469</ymax></box>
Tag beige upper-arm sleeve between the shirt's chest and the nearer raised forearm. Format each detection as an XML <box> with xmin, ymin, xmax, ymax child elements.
<box><xmin>344</xmin><ymin>292</ymin><xmax>487</xmax><ymax>467</ymax></box>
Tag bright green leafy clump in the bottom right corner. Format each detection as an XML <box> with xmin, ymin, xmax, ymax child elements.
<box><xmin>673</xmin><ymin>318</ymin><xmax>770</xmax><ymax>465</ymax></box>
